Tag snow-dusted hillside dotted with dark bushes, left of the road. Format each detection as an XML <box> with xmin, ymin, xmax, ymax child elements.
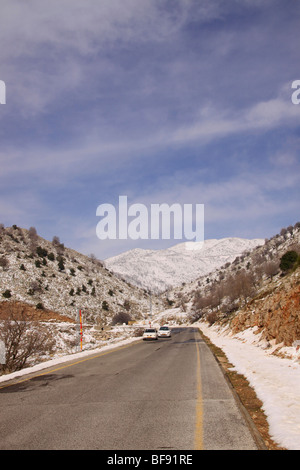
<box><xmin>0</xmin><ymin>226</ymin><xmax>162</xmax><ymax>325</ymax></box>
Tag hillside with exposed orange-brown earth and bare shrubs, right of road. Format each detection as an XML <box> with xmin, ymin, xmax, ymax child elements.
<box><xmin>165</xmin><ymin>224</ymin><xmax>300</xmax><ymax>346</ymax></box>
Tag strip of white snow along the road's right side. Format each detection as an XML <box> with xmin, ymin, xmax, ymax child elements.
<box><xmin>197</xmin><ymin>322</ymin><xmax>300</xmax><ymax>450</ymax></box>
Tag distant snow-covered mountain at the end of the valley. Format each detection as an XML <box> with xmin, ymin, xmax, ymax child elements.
<box><xmin>105</xmin><ymin>238</ymin><xmax>264</xmax><ymax>293</ymax></box>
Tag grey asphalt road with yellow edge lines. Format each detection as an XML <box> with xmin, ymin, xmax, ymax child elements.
<box><xmin>0</xmin><ymin>328</ymin><xmax>257</xmax><ymax>451</ymax></box>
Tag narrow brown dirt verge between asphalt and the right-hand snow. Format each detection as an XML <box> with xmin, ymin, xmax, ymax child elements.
<box><xmin>199</xmin><ymin>330</ymin><xmax>286</xmax><ymax>450</ymax></box>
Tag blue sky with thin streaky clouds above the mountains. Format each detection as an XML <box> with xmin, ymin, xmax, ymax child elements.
<box><xmin>0</xmin><ymin>0</ymin><xmax>300</xmax><ymax>259</ymax></box>
